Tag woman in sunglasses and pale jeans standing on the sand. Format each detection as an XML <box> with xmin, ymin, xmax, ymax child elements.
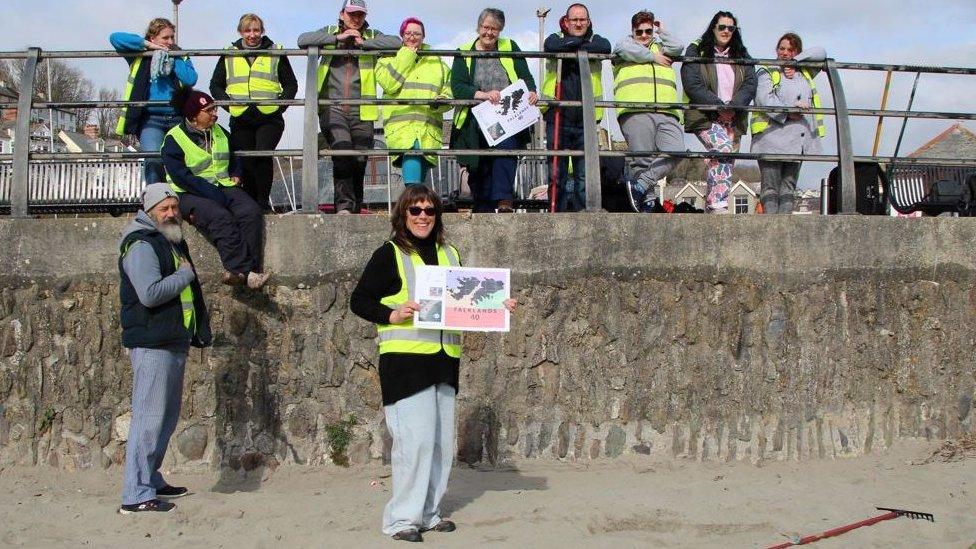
<box><xmin>349</xmin><ymin>185</ymin><xmax>517</xmax><ymax>541</ymax></box>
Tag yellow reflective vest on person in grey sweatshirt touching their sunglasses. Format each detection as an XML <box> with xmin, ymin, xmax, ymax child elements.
<box><xmin>613</xmin><ymin>43</ymin><xmax>682</xmax><ymax>122</ymax></box>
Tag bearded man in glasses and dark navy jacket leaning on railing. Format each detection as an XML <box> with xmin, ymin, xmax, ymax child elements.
<box><xmin>542</xmin><ymin>4</ymin><xmax>610</xmax><ymax>212</ymax></box>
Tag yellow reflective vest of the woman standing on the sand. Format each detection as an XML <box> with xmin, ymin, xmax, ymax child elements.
<box><xmin>376</xmin><ymin>242</ymin><xmax>461</xmax><ymax>358</ymax></box>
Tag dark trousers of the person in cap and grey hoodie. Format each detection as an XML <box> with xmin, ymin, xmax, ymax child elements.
<box><xmin>319</xmin><ymin>107</ymin><xmax>373</xmax><ymax>213</ymax></box>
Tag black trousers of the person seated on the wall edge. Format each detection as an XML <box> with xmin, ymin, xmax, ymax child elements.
<box><xmin>180</xmin><ymin>187</ymin><xmax>264</xmax><ymax>274</ymax></box>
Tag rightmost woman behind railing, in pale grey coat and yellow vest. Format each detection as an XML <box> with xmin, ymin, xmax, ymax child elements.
<box><xmin>749</xmin><ymin>32</ymin><xmax>827</xmax><ymax>214</ymax></box>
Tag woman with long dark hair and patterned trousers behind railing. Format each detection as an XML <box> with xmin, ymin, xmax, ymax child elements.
<box><xmin>681</xmin><ymin>11</ymin><xmax>756</xmax><ymax>213</ymax></box>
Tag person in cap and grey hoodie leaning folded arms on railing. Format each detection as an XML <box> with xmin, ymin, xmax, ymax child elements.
<box><xmin>298</xmin><ymin>0</ymin><xmax>401</xmax><ymax>214</ymax></box>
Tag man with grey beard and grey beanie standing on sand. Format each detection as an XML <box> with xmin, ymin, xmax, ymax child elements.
<box><xmin>119</xmin><ymin>183</ymin><xmax>212</xmax><ymax>515</ymax></box>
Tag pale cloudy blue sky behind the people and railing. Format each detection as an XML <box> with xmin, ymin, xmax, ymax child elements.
<box><xmin>0</xmin><ymin>0</ymin><xmax>976</xmax><ymax>187</ymax></box>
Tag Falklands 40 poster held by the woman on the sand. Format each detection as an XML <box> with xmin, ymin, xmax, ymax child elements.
<box><xmin>413</xmin><ymin>265</ymin><xmax>511</xmax><ymax>332</ymax></box>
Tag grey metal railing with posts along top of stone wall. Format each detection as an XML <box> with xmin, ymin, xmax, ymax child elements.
<box><xmin>0</xmin><ymin>47</ymin><xmax>976</xmax><ymax>217</ymax></box>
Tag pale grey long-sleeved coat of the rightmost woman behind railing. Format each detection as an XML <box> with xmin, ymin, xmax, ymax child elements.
<box><xmin>751</xmin><ymin>47</ymin><xmax>827</xmax><ymax>154</ymax></box>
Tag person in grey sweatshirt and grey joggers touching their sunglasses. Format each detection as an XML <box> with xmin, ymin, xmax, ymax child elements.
<box><xmin>612</xmin><ymin>11</ymin><xmax>685</xmax><ymax>212</ymax></box>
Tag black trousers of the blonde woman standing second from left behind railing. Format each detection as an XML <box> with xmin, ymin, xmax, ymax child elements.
<box><xmin>230</xmin><ymin>115</ymin><xmax>285</xmax><ymax>210</ymax></box>
